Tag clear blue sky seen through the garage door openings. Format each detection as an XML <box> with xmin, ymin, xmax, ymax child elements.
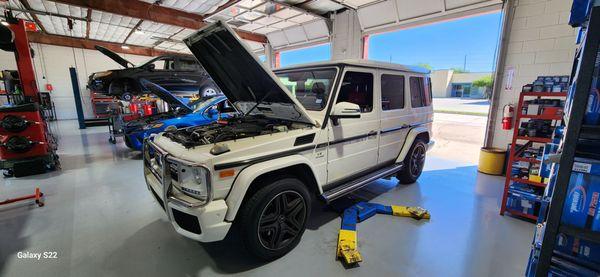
<box><xmin>281</xmin><ymin>13</ymin><xmax>501</xmax><ymax>72</ymax></box>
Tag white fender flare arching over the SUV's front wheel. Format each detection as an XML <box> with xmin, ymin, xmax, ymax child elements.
<box><xmin>225</xmin><ymin>155</ymin><xmax>322</xmax><ymax>221</ymax></box>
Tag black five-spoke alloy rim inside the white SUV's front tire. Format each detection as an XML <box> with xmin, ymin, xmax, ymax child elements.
<box><xmin>258</xmin><ymin>190</ymin><xmax>306</xmax><ymax>250</ymax></box>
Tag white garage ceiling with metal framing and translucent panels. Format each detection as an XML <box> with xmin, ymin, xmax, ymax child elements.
<box><xmin>0</xmin><ymin>0</ymin><xmax>502</xmax><ymax>55</ymax></box>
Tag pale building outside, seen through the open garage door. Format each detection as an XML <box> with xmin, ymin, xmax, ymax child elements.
<box><xmin>431</xmin><ymin>69</ymin><xmax>492</xmax><ymax>99</ymax></box>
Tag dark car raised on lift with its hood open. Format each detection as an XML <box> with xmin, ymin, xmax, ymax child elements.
<box><xmin>87</xmin><ymin>45</ymin><xmax>220</xmax><ymax>101</ymax></box>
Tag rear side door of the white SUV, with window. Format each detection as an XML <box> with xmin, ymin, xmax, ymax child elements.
<box><xmin>378</xmin><ymin>70</ymin><xmax>413</xmax><ymax>164</ymax></box>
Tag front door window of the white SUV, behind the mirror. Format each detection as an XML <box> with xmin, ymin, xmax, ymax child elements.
<box><xmin>337</xmin><ymin>71</ymin><xmax>373</xmax><ymax>113</ymax></box>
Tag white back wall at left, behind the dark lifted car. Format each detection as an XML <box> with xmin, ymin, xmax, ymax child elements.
<box><xmin>0</xmin><ymin>43</ymin><xmax>150</xmax><ymax>119</ymax></box>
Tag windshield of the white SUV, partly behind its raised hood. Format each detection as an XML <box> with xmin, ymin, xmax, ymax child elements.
<box><xmin>275</xmin><ymin>68</ymin><xmax>337</xmax><ymax>111</ymax></box>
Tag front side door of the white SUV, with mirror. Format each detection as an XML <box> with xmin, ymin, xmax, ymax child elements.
<box><xmin>327</xmin><ymin>67</ymin><xmax>379</xmax><ymax>184</ymax></box>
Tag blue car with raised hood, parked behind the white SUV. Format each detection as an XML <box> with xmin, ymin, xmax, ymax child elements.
<box><xmin>123</xmin><ymin>79</ymin><xmax>237</xmax><ymax>150</ymax></box>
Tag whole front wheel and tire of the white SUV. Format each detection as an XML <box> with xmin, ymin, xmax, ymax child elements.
<box><xmin>240</xmin><ymin>178</ymin><xmax>311</xmax><ymax>261</ymax></box>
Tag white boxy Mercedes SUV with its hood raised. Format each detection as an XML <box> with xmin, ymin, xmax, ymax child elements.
<box><xmin>143</xmin><ymin>22</ymin><xmax>433</xmax><ymax>260</ymax></box>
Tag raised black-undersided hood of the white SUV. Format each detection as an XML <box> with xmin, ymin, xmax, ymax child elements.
<box><xmin>184</xmin><ymin>21</ymin><xmax>317</xmax><ymax>125</ymax></box>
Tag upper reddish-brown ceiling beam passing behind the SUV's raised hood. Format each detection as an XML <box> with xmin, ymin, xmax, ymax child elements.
<box><xmin>53</xmin><ymin>0</ymin><xmax>267</xmax><ymax>43</ymax></box>
